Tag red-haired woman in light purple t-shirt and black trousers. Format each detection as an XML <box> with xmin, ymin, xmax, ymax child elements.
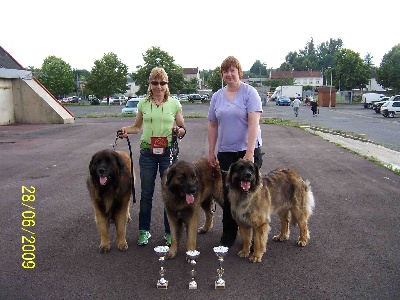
<box><xmin>208</xmin><ymin>56</ymin><xmax>263</xmax><ymax>247</ymax></box>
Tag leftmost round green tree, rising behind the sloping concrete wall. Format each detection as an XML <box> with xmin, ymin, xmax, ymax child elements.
<box><xmin>37</xmin><ymin>56</ymin><xmax>75</xmax><ymax>98</ymax></box>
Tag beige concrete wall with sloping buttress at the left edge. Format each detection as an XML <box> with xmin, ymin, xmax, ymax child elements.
<box><xmin>0</xmin><ymin>79</ymin><xmax>74</xmax><ymax>125</ymax></box>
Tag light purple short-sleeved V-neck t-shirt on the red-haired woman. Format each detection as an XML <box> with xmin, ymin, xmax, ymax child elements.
<box><xmin>208</xmin><ymin>82</ymin><xmax>262</xmax><ymax>152</ymax></box>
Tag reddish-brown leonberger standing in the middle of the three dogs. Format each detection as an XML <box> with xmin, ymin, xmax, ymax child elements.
<box><xmin>161</xmin><ymin>158</ymin><xmax>223</xmax><ymax>259</ymax></box>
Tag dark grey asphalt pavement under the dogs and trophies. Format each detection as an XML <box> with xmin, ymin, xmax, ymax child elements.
<box><xmin>0</xmin><ymin>113</ymin><xmax>400</xmax><ymax>299</ymax></box>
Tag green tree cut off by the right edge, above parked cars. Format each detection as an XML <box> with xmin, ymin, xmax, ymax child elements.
<box><xmin>376</xmin><ymin>44</ymin><xmax>400</xmax><ymax>93</ymax></box>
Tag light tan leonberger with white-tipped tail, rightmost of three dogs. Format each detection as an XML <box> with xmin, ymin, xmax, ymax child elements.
<box><xmin>226</xmin><ymin>159</ymin><xmax>314</xmax><ymax>262</ymax></box>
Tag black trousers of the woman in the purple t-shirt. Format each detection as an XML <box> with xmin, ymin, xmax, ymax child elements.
<box><xmin>217</xmin><ymin>147</ymin><xmax>264</xmax><ymax>247</ymax></box>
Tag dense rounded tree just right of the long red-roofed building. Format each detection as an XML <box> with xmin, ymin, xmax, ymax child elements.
<box><xmin>334</xmin><ymin>49</ymin><xmax>370</xmax><ymax>90</ymax></box>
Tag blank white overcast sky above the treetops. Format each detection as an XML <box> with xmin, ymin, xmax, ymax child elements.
<box><xmin>0</xmin><ymin>0</ymin><xmax>400</xmax><ymax>72</ymax></box>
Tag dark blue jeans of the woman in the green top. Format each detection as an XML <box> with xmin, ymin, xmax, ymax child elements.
<box><xmin>139</xmin><ymin>149</ymin><xmax>170</xmax><ymax>234</ymax></box>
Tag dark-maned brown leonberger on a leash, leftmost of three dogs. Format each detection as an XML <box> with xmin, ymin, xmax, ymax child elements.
<box><xmin>86</xmin><ymin>150</ymin><xmax>132</xmax><ymax>253</ymax></box>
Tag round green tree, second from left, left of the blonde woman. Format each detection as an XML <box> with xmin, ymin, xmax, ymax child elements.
<box><xmin>86</xmin><ymin>52</ymin><xmax>128</xmax><ymax>103</ymax></box>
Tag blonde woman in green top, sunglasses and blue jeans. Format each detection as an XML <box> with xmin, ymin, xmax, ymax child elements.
<box><xmin>120</xmin><ymin>68</ymin><xmax>186</xmax><ymax>245</ymax></box>
